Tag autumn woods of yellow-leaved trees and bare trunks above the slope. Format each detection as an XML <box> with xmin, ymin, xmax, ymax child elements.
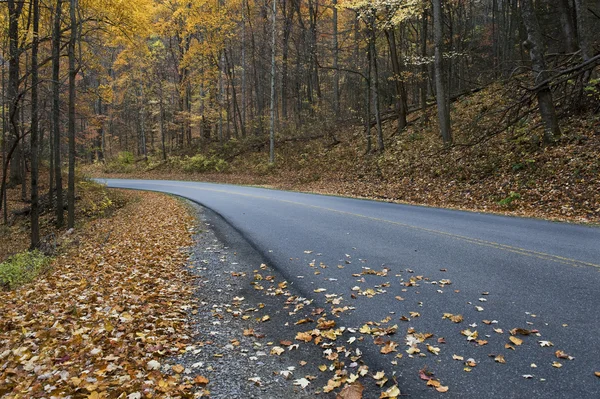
<box><xmin>0</xmin><ymin>0</ymin><xmax>600</xmax><ymax>247</ymax></box>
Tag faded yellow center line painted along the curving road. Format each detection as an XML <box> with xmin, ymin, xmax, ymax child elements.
<box><xmin>130</xmin><ymin>183</ymin><xmax>600</xmax><ymax>269</ymax></box>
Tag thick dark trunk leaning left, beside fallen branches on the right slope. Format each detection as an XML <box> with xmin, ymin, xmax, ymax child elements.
<box><xmin>521</xmin><ymin>0</ymin><xmax>560</xmax><ymax>143</ymax></box>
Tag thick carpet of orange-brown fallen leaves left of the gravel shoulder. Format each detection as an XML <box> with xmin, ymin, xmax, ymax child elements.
<box><xmin>0</xmin><ymin>193</ymin><xmax>194</xmax><ymax>399</ymax></box>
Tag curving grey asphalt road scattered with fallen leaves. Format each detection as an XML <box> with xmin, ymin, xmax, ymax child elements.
<box><xmin>101</xmin><ymin>179</ymin><xmax>600</xmax><ymax>398</ymax></box>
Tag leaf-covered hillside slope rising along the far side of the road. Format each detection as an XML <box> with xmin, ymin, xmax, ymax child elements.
<box><xmin>84</xmin><ymin>84</ymin><xmax>600</xmax><ymax>223</ymax></box>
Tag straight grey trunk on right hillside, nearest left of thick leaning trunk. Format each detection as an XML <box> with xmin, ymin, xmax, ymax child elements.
<box><xmin>433</xmin><ymin>0</ymin><xmax>452</xmax><ymax>145</ymax></box>
